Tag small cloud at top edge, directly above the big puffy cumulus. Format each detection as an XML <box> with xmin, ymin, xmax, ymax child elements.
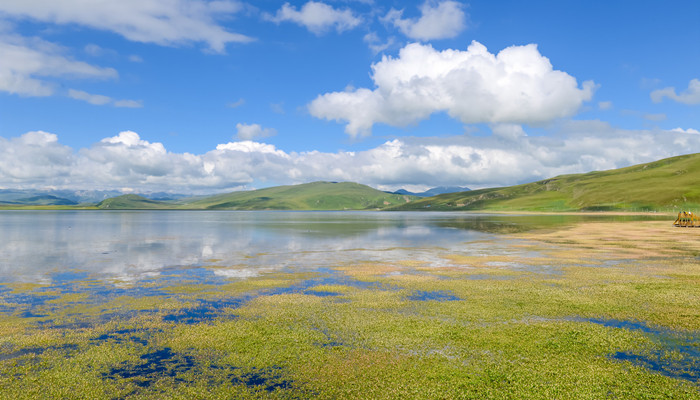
<box><xmin>384</xmin><ymin>0</ymin><xmax>467</xmax><ymax>41</ymax></box>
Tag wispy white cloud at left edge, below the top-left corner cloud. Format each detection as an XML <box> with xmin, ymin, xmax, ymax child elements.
<box><xmin>0</xmin><ymin>35</ymin><xmax>118</xmax><ymax>96</ymax></box>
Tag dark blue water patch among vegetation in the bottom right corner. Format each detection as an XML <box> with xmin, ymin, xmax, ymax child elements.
<box><xmin>574</xmin><ymin>318</ymin><xmax>700</xmax><ymax>383</ymax></box>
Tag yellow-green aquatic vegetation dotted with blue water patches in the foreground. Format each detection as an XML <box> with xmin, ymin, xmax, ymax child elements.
<box><xmin>0</xmin><ymin>217</ymin><xmax>700</xmax><ymax>399</ymax></box>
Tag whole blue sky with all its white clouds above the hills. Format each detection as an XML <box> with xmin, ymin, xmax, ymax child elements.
<box><xmin>0</xmin><ymin>0</ymin><xmax>700</xmax><ymax>194</ymax></box>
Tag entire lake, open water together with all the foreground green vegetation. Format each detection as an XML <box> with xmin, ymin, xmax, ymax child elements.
<box><xmin>0</xmin><ymin>211</ymin><xmax>700</xmax><ymax>399</ymax></box>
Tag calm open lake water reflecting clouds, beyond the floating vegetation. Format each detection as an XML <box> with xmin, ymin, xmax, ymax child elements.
<box><xmin>0</xmin><ymin>211</ymin><xmax>668</xmax><ymax>284</ymax></box>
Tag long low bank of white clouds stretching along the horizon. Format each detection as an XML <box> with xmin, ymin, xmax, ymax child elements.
<box><xmin>0</xmin><ymin>126</ymin><xmax>700</xmax><ymax>193</ymax></box>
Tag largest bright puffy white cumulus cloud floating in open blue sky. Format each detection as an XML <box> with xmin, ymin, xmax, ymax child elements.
<box><xmin>308</xmin><ymin>41</ymin><xmax>595</xmax><ymax>137</ymax></box>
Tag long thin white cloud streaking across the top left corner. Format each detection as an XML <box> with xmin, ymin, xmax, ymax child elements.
<box><xmin>0</xmin><ymin>0</ymin><xmax>252</xmax><ymax>52</ymax></box>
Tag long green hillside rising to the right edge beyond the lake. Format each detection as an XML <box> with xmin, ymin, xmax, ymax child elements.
<box><xmin>392</xmin><ymin>154</ymin><xmax>700</xmax><ymax>211</ymax></box>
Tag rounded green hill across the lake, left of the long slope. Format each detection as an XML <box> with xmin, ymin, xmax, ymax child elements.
<box><xmin>181</xmin><ymin>182</ymin><xmax>415</xmax><ymax>210</ymax></box>
